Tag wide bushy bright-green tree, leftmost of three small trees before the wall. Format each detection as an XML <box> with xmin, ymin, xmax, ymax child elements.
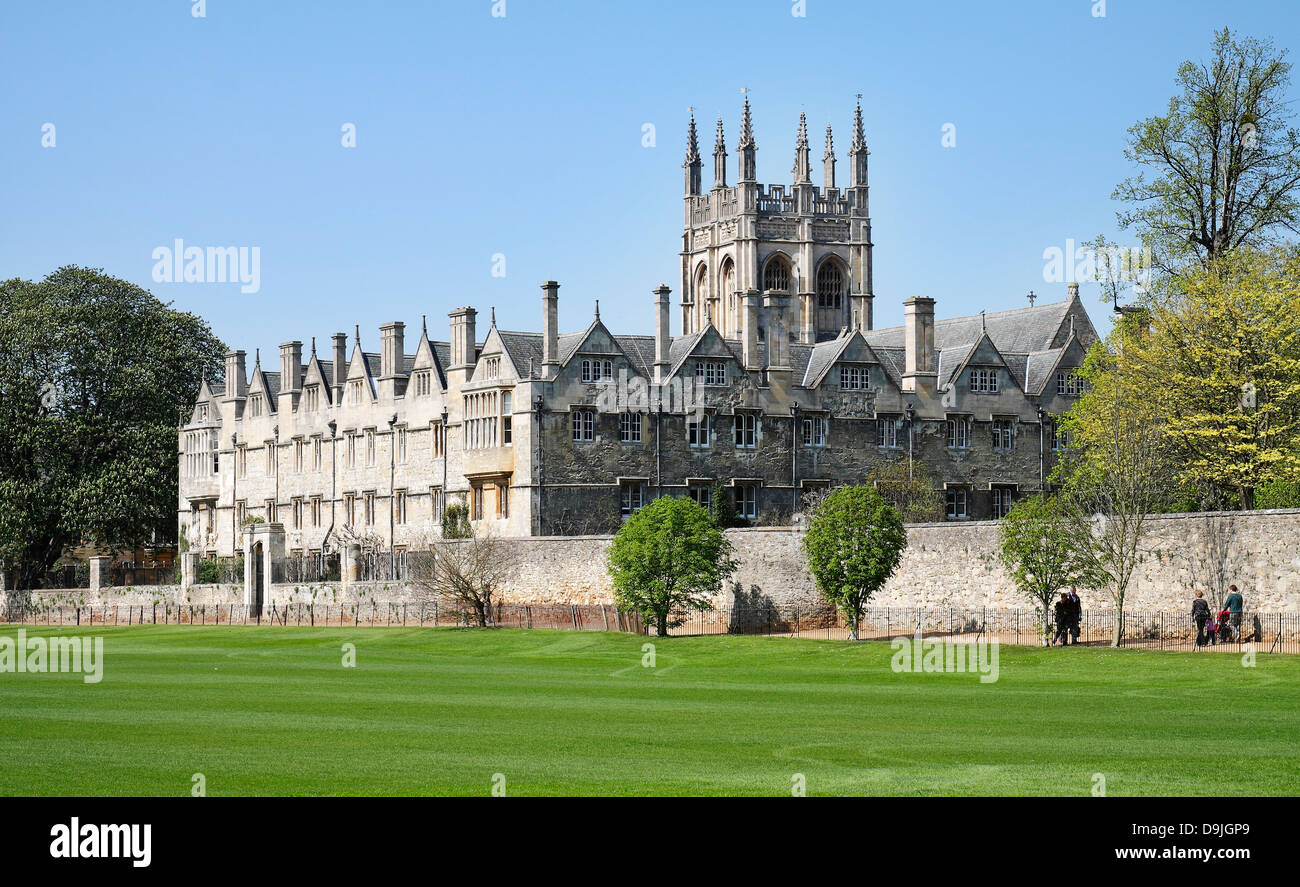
<box><xmin>608</xmin><ymin>496</ymin><xmax>736</xmax><ymax>637</ymax></box>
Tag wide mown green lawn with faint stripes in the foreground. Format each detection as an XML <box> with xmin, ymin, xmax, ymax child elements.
<box><xmin>0</xmin><ymin>626</ymin><xmax>1300</xmax><ymax>796</ymax></box>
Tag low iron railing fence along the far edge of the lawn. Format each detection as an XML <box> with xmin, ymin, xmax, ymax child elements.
<box><xmin>0</xmin><ymin>596</ymin><xmax>1300</xmax><ymax>653</ymax></box>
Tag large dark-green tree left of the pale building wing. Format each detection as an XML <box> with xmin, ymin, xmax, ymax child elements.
<box><xmin>0</xmin><ymin>265</ymin><xmax>225</xmax><ymax>588</ymax></box>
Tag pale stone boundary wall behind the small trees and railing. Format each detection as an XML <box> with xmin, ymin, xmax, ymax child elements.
<box><xmin>10</xmin><ymin>510</ymin><xmax>1300</xmax><ymax>616</ymax></box>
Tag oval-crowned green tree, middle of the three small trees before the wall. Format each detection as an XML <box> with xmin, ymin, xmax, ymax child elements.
<box><xmin>803</xmin><ymin>486</ymin><xmax>907</xmax><ymax>640</ymax></box>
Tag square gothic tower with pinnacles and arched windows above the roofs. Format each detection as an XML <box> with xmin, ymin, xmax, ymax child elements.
<box><xmin>681</xmin><ymin>98</ymin><xmax>872</xmax><ymax>343</ymax></box>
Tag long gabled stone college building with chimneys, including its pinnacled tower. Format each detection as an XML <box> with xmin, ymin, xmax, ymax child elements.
<box><xmin>178</xmin><ymin>101</ymin><xmax>1097</xmax><ymax>554</ymax></box>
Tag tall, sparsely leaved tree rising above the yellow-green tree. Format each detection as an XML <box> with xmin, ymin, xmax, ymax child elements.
<box><xmin>1114</xmin><ymin>29</ymin><xmax>1300</xmax><ymax>271</ymax></box>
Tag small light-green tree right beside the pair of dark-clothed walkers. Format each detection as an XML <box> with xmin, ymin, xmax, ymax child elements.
<box><xmin>997</xmin><ymin>496</ymin><xmax>1080</xmax><ymax>646</ymax></box>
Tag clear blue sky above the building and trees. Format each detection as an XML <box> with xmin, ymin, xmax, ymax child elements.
<box><xmin>0</xmin><ymin>0</ymin><xmax>1300</xmax><ymax>356</ymax></box>
